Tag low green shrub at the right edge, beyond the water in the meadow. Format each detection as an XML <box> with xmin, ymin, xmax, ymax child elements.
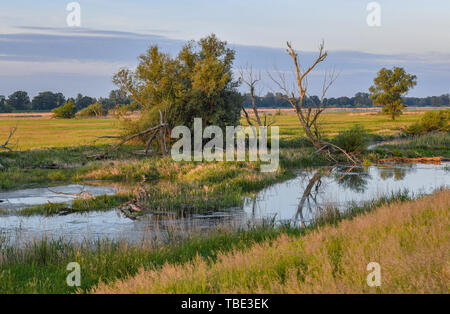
<box><xmin>406</xmin><ymin>109</ymin><xmax>450</xmax><ymax>135</ymax></box>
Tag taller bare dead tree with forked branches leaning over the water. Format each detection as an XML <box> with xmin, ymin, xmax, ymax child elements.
<box><xmin>268</xmin><ymin>41</ymin><xmax>357</xmax><ymax>164</ymax></box>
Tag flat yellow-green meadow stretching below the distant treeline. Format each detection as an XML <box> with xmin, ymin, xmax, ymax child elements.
<box><xmin>0</xmin><ymin>109</ymin><xmax>436</xmax><ymax>150</ymax></box>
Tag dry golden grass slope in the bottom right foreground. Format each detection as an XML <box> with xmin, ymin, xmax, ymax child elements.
<box><xmin>93</xmin><ymin>190</ymin><xmax>450</xmax><ymax>293</ymax></box>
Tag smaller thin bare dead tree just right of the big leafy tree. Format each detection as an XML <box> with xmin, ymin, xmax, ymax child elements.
<box><xmin>239</xmin><ymin>66</ymin><xmax>274</xmax><ymax>127</ymax></box>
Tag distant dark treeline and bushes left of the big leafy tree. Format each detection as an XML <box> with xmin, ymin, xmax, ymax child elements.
<box><xmin>0</xmin><ymin>90</ymin><xmax>132</xmax><ymax>113</ymax></box>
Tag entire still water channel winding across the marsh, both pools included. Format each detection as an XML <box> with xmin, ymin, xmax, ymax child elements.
<box><xmin>0</xmin><ymin>164</ymin><xmax>450</xmax><ymax>244</ymax></box>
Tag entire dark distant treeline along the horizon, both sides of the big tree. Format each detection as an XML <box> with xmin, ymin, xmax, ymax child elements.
<box><xmin>0</xmin><ymin>90</ymin><xmax>450</xmax><ymax>113</ymax></box>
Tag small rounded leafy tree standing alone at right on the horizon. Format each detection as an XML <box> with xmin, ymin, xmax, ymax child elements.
<box><xmin>369</xmin><ymin>67</ymin><xmax>417</xmax><ymax>120</ymax></box>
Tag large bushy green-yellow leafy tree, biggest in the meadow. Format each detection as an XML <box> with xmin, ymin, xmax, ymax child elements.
<box><xmin>113</xmin><ymin>35</ymin><xmax>242</xmax><ymax>140</ymax></box>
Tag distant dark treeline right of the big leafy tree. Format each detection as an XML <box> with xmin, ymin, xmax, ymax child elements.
<box><xmin>244</xmin><ymin>93</ymin><xmax>450</xmax><ymax>108</ymax></box>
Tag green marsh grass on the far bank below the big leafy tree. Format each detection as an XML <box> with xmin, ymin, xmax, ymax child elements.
<box><xmin>0</xmin><ymin>148</ymin><xmax>316</xmax><ymax>214</ymax></box>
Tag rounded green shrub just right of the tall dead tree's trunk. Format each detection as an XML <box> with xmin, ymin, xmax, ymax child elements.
<box><xmin>334</xmin><ymin>124</ymin><xmax>369</xmax><ymax>153</ymax></box>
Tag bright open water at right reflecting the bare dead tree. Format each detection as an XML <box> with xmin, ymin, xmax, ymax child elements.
<box><xmin>244</xmin><ymin>164</ymin><xmax>450</xmax><ymax>225</ymax></box>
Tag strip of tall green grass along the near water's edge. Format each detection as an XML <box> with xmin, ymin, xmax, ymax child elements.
<box><xmin>0</xmin><ymin>192</ymin><xmax>420</xmax><ymax>293</ymax></box>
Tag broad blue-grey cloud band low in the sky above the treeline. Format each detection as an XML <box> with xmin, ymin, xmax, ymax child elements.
<box><xmin>0</xmin><ymin>26</ymin><xmax>450</xmax><ymax>96</ymax></box>
